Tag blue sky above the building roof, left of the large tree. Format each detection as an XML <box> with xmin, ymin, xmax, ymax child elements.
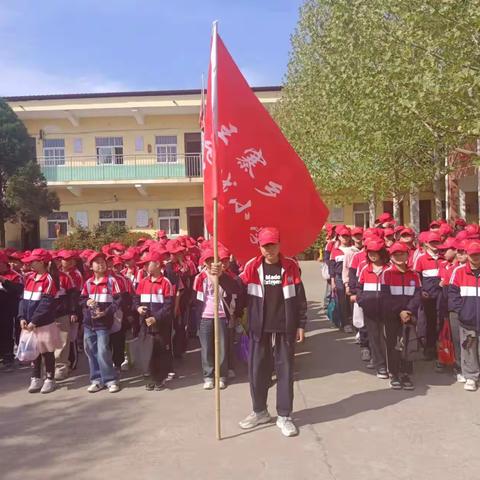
<box><xmin>0</xmin><ymin>0</ymin><xmax>303</xmax><ymax>96</ymax></box>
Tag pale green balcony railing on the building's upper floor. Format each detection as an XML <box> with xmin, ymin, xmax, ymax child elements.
<box><xmin>37</xmin><ymin>153</ymin><xmax>203</xmax><ymax>182</ymax></box>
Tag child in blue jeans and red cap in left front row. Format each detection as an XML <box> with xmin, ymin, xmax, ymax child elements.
<box><xmin>80</xmin><ymin>252</ymin><xmax>122</xmax><ymax>393</ymax></box>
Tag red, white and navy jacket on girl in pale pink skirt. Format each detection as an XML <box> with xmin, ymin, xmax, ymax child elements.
<box><xmin>18</xmin><ymin>272</ymin><xmax>58</xmax><ymax>327</ymax></box>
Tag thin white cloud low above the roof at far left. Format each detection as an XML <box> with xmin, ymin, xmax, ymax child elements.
<box><xmin>0</xmin><ymin>60</ymin><xmax>129</xmax><ymax>96</ymax></box>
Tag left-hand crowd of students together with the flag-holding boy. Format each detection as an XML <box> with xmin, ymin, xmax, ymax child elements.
<box><xmin>0</xmin><ymin>227</ymin><xmax>307</xmax><ymax>436</ymax></box>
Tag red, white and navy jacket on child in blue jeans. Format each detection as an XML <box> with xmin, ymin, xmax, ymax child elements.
<box><xmin>80</xmin><ymin>274</ymin><xmax>122</xmax><ymax>330</ymax></box>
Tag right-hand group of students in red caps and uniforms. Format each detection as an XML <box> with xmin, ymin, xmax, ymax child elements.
<box><xmin>323</xmin><ymin>213</ymin><xmax>480</xmax><ymax>391</ymax></box>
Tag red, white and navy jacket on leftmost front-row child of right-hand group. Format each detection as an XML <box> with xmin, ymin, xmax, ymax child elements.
<box><xmin>357</xmin><ymin>262</ymin><xmax>388</xmax><ymax>321</ymax></box>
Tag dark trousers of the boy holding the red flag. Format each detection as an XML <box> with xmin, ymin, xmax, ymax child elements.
<box><xmin>248</xmin><ymin>332</ymin><xmax>296</xmax><ymax>417</ymax></box>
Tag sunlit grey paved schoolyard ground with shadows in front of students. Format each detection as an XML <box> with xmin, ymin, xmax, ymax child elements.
<box><xmin>0</xmin><ymin>262</ymin><xmax>480</xmax><ymax>480</ymax></box>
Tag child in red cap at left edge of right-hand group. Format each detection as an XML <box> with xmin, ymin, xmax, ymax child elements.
<box><xmin>329</xmin><ymin>225</ymin><xmax>354</xmax><ymax>333</ymax></box>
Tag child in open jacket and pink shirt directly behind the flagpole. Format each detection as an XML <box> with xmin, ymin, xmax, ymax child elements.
<box><xmin>194</xmin><ymin>248</ymin><xmax>240</xmax><ymax>390</ymax></box>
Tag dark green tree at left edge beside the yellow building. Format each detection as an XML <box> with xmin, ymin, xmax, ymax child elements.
<box><xmin>0</xmin><ymin>99</ymin><xmax>60</xmax><ymax>246</ymax></box>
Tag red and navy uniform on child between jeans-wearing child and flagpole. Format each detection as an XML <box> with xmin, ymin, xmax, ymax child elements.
<box><xmin>133</xmin><ymin>275</ymin><xmax>174</xmax><ymax>384</ymax></box>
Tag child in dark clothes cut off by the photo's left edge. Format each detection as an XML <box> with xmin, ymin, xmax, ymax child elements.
<box><xmin>0</xmin><ymin>251</ymin><xmax>23</xmax><ymax>372</ymax></box>
